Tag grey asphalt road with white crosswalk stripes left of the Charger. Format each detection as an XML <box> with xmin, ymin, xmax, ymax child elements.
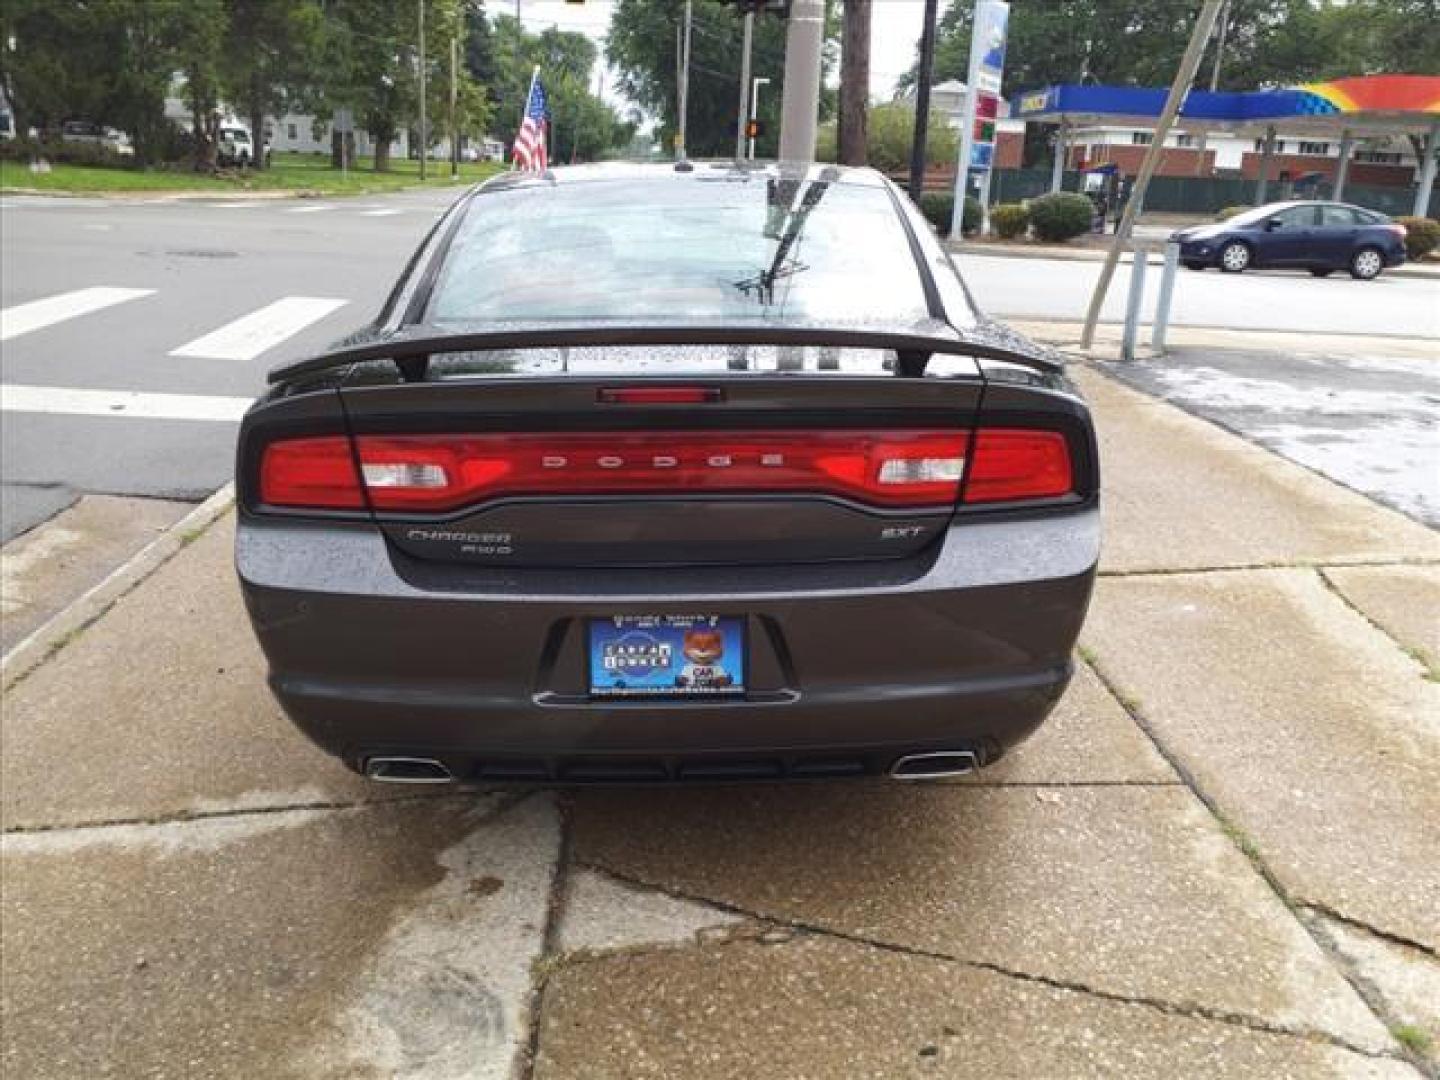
<box><xmin>0</xmin><ymin>189</ymin><xmax>458</xmax><ymax>540</ymax></box>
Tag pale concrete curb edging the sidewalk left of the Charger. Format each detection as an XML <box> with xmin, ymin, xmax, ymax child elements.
<box><xmin>0</xmin><ymin>482</ymin><xmax>235</xmax><ymax>693</ymax></box>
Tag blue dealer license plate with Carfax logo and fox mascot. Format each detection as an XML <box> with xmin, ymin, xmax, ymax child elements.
<box><xmin>589</xmin><ymin>615</ymin><xmax>746</xmax><ymax>698</ymax></box>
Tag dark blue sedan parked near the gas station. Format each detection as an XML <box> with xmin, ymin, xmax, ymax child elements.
<box><xmin>1171</xmin><ymin>202</ymin><xmax>1405</xmax><ymax>281</ymax></box>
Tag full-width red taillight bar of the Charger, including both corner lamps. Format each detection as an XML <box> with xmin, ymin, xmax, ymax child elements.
<box><xmin>259</xmin><ymin>429</ymin><xmax>1074</xmax><ymax>513</ymax></box>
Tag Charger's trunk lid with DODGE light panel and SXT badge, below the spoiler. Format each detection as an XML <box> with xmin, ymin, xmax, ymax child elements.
<box><xmin>340</xmin><ymin>344</ymin><xmax>984</xmax><ymax>567</ymax></box>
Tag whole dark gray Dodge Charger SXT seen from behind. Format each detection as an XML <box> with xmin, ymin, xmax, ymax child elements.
<box><xmin>236</xmin><ymin>164</ymin><xmax>1100</xmax><ymax>783</ymax></box>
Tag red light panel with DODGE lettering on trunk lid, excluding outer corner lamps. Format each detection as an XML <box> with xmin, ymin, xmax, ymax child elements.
<box><xmin>348</xmin><ymin>431</ymin><xmax>968</xmax><ymax>511</ymax></box>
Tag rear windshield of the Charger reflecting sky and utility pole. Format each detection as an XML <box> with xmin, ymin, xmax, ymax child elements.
<box><xmin>426</xmin><ymin>173</ymin><xmax>927</xmax><ymax>325</ymax></box>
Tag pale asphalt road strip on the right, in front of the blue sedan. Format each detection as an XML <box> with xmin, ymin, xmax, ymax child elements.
<box><xmin>959</xmin><ymin>255</ymin><xmax>1440</xmax><ymax>338</ymax></box>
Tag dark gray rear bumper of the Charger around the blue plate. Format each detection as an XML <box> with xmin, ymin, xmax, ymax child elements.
<box><xmin>236</xmin><ymin>507</ymin><xmax>1100</xmax><ymax>782</ymax></box>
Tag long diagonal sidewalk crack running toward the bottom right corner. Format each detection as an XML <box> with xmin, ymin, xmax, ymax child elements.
<box><xmin>576</xmin><ymin>860</ymin><xmax>1408</xmax><ymax>1060</ymax></box>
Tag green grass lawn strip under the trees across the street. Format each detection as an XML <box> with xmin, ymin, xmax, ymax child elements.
<box><xmin>0</xmin><ymin>154</ymin><xmax>504</xmax><ymax>196</ymax></box>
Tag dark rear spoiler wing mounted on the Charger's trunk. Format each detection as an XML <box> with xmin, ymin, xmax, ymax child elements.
<box><xmin>268</xmin><ymin>320</ymin><xmax>1064</xmax><ymax>383</ymax></box>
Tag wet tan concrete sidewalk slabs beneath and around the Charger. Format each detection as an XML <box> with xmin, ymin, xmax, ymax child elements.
<box><xmin>0</xmin><ymin>370</ymin><xmax>1440</xmax><ymax>1080</ymax></box>
